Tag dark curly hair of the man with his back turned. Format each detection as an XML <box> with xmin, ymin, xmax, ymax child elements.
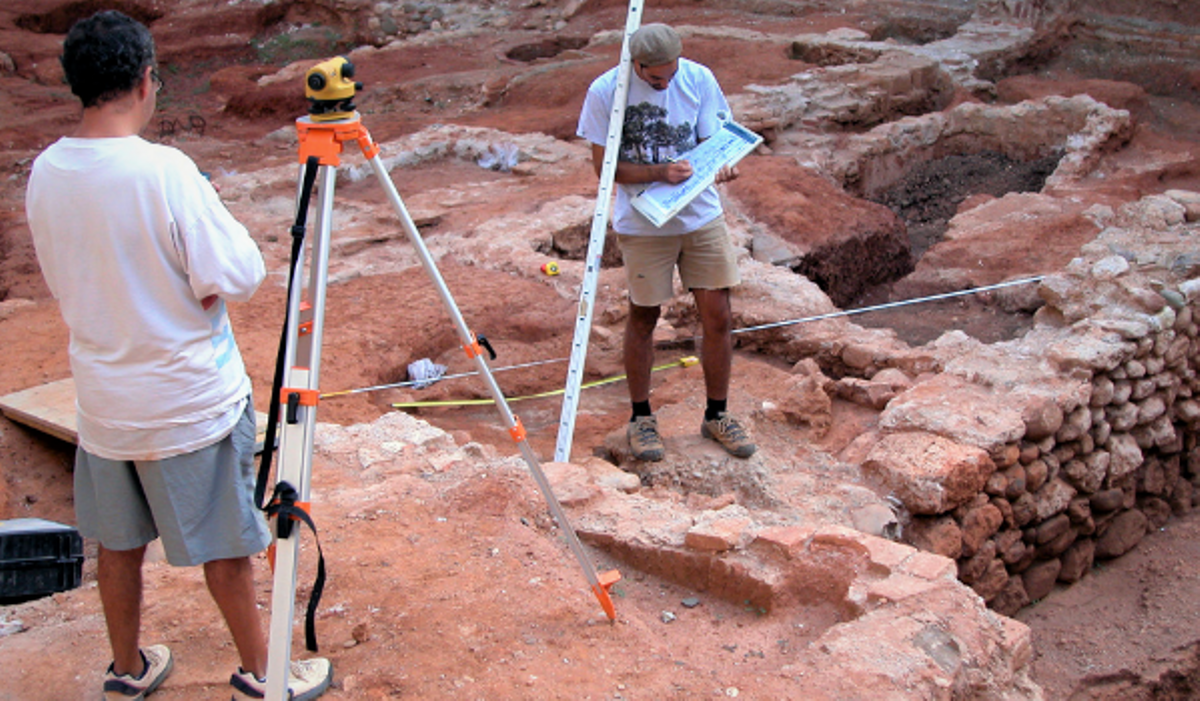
<box><xmin>60</xmin><ymin>10</ymin><xmax>155</xmax><ymax>107</ymax></box>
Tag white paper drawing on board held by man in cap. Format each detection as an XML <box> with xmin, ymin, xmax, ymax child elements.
<box><xmin>630</xmin><ymin>121</ymin><xmax>762</xmax><ymax>227</ymax></box>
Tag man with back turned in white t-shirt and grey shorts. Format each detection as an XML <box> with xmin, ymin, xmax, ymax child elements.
<box><xmin>25</xmin><ymin>11</ymin><xmax>332</xmax><ymax>701</ymax></box>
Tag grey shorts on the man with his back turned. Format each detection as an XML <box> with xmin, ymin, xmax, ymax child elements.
<box><xmin>74</xmin><ymin>401</ymin><xmax>271</xmax><ymax>567</ymax></box>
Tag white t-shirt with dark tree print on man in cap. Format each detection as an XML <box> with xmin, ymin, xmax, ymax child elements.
<box><xmin>576</xmin><ymin>59</ymin><xmax>731</xmax><ymax>235</ymax></box>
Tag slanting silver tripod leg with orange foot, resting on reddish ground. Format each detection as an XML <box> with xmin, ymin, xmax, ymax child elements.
<box><xmin>370</xmin><ymin>154</ymin><xmax>620</xmax><ymax>621</ymax></box>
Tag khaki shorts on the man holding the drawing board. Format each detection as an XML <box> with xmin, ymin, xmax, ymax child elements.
<box><xmin>617</xmin><ymin>215</ymin><xmax>742</xmax><ymax>306</ymax></box>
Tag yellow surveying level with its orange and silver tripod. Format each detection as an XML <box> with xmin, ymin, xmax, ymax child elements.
<box><xmin>256</xmin><ymin>58</ymin><xmax>620</xmax><ymax>701</ymax></box>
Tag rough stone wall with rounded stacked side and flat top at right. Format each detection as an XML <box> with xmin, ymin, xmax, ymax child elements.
<box><xmin>863</xmin><ymin>191</ymin><xmax>1200</xmax><ymax>613</ymax></box>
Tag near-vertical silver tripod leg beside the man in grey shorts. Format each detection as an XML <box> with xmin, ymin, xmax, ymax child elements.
<box><xmin>266</xmin><ymin>166</ymin><xmax>337</xmax><ymax>701</ymax></box>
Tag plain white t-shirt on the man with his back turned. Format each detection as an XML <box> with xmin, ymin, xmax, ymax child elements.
<box><xmin>25</xmin><ymin>137</ymin><xmax>265</xmax><ymax>460</ymax></box>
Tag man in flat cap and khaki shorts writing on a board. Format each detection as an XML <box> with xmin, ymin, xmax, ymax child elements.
<box><xmin>578</xmin><ymin>24</ymin><xmax>756</xmax><ymax>461</ymax></box>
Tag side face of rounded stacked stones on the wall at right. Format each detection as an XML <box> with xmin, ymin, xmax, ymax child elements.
<box><xmin>988</xmin><ymin>290</ymin><xmax>1200</xmax><ymax>612</ymax></box>
